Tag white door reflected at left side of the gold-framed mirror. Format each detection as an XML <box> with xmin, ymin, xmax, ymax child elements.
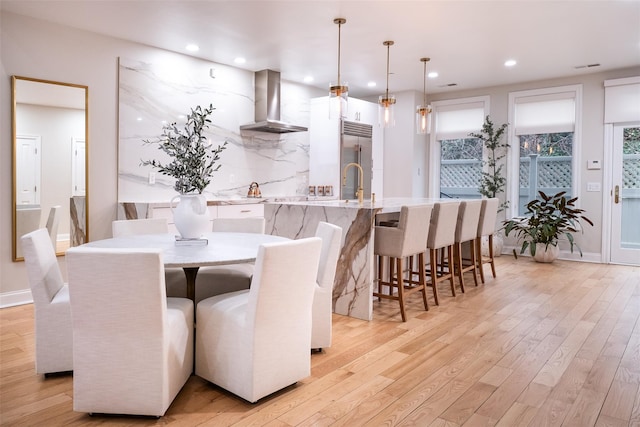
<box><xmin>16</xmin><ymin>135</ymin><xmax>41</xmax><ymax>205</ymax></box>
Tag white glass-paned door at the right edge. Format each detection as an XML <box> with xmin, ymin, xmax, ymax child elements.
<box><xmin>611</xmin><ymin>123</ymin><xmax>640</xmax><ymax>265</ymax></box>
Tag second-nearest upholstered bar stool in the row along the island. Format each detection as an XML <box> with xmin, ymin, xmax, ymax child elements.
<box><xmin>426</xmin><ymin>201</ymin><xmax>460</xmax><ymax>305</ymax></box>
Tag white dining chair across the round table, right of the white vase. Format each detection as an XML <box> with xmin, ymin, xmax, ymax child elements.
<box><xmin>195</xmin><ymin>217</ymin><xmax>265</xmax><ymax>304</ymax></box>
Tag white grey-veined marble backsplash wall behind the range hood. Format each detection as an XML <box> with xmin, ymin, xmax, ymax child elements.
<box><xmin>118</xmin><ymin>54</ymin><xmax>318</xmax><ymax>202</ymax></box>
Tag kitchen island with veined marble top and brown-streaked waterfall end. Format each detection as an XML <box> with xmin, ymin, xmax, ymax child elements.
<box><xmin>264</xmin><ymin>198</ymin><xmax>451</xmax><ymax>320</ymax></box>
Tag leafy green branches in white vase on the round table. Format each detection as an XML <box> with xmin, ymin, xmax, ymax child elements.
<box><xmin>141</xmin><ymin>105</ymin><xmax>227</xmax><ymax>239</ymax></box>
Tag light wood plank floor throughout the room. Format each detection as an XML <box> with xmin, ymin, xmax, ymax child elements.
<box><xmin>0</xmin><ymin>256</ymin><xmax>640</xmax><ymax>427</ymax></box>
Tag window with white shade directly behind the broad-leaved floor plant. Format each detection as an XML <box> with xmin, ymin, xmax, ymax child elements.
<box><xmin>509</xmin><ymin>85</ymin><xmax>582</xmax><ymax>216</ymax></box>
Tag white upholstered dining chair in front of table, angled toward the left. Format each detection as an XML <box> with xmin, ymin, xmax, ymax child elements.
<box><xmin>195</xmin><ymin>237</ymin><xmax>322</xmax><ymax>403</ymax></box>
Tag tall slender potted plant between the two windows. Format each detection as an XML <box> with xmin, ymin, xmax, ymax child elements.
<box><xmin>469</xmin><ymin>116</ymin><xmax>509</xmax><ymax>256</ymax></box>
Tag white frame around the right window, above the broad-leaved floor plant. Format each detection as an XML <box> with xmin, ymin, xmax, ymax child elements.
<box><xmin>506</xmin><ymin>84</ymin><xmax>582</xmax><ymax>219</ymax></box>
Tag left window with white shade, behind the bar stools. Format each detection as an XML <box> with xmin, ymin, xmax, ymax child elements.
<box><xmin>429</xmin><ymin>97</ymin><xmax>489</xmax><ymax>198</ymax></box>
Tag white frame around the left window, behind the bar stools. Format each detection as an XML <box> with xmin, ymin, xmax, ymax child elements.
<box><xmin>428</xmin><ymin>95</ymin><xmax>491</xmax><ymax>198</ymax></box>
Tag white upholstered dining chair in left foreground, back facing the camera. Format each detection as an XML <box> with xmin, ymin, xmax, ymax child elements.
<box><xmin>67</xmin><ymin>246</ymin><xmax>194</xmax><ymax>416</ymax></box>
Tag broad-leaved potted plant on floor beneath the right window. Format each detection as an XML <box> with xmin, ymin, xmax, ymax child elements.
<box><xmin>503</xmin><ymin>191</ymin><xmax>593</xmax><ymax>262</ymax></box>
